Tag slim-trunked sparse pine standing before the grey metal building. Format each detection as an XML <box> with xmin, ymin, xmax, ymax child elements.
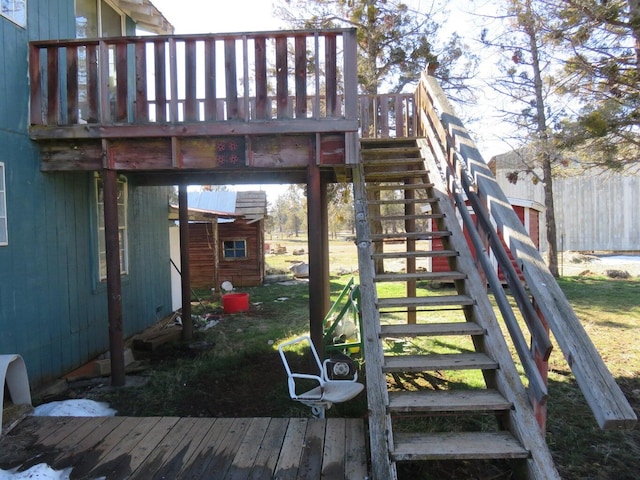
<box><xmin>481</xmin><ymin>0</ymin><xmax>562</xmax><ymax>277</ymax></box>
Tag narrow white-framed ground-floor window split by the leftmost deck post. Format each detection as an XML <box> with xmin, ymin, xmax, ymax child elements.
<box><xmin>96</xmin><ymin>177</ymin><xmax>129</xmax><ymax>282</ymax></box>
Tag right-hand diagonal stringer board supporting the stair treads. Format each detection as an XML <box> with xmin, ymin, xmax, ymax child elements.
<box><xmin>417</xmin><ymin>139</ymin><xmax>560</xmax><ymax>480</ymax></box>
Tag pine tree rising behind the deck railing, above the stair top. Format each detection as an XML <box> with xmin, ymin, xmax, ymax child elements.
<box><xmin>276</xmin><ymin>0</ymin><xmax>477</xmax><ymax>97</ymax></box>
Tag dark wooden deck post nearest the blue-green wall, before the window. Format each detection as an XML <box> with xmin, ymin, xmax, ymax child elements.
<box><xmin>102</xmin><ymin>170</ymin><xmax>126</xmax><ymax>387</ymax></box>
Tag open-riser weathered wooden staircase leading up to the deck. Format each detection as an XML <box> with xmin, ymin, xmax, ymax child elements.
<box><xmin>354</xmin><ymin>139</ymin><xmax>559</xmax><ymax>479</ymax></box>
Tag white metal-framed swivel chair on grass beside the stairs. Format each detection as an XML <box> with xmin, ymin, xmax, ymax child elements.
<box><xmin>278</xmin><ymin>335</ymin><xmax>364</xmax><ymax>418</ymax></box>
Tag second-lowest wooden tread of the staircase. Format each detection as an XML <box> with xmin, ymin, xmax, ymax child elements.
<box><xmin>389</xmin><ymin>390</ymin><xmax>512</xmax><ymax>412</ymax></box>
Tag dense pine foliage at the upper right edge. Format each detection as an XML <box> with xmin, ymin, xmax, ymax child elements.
<box><xmin>553</xmin><ymin>0</ymin><xmax>640</xmax><ymax>169</ymax></box>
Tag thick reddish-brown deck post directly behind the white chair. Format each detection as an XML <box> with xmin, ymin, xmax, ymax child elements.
<box><xmin>307</xmin><ymin>163</ymin><xmax>330</xmax><ymax>357</ymax></box>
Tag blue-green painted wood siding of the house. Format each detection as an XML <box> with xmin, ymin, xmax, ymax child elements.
<box><xmin>0</xmin><ymin>0</ymin><xmax>171</xmax><ymax>386</ymax></box>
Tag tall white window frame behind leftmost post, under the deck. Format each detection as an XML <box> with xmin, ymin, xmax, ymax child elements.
<box><xmin>93</xmin><ymin>174</ymin><xmax>130</xmax><ymax>285</ymax></box>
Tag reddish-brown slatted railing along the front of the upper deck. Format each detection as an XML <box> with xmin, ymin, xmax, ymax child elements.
<box><xmin>30</xmin><ymin>29</ymin><xmax>358</xmax><ymax>134</ymax></box>
